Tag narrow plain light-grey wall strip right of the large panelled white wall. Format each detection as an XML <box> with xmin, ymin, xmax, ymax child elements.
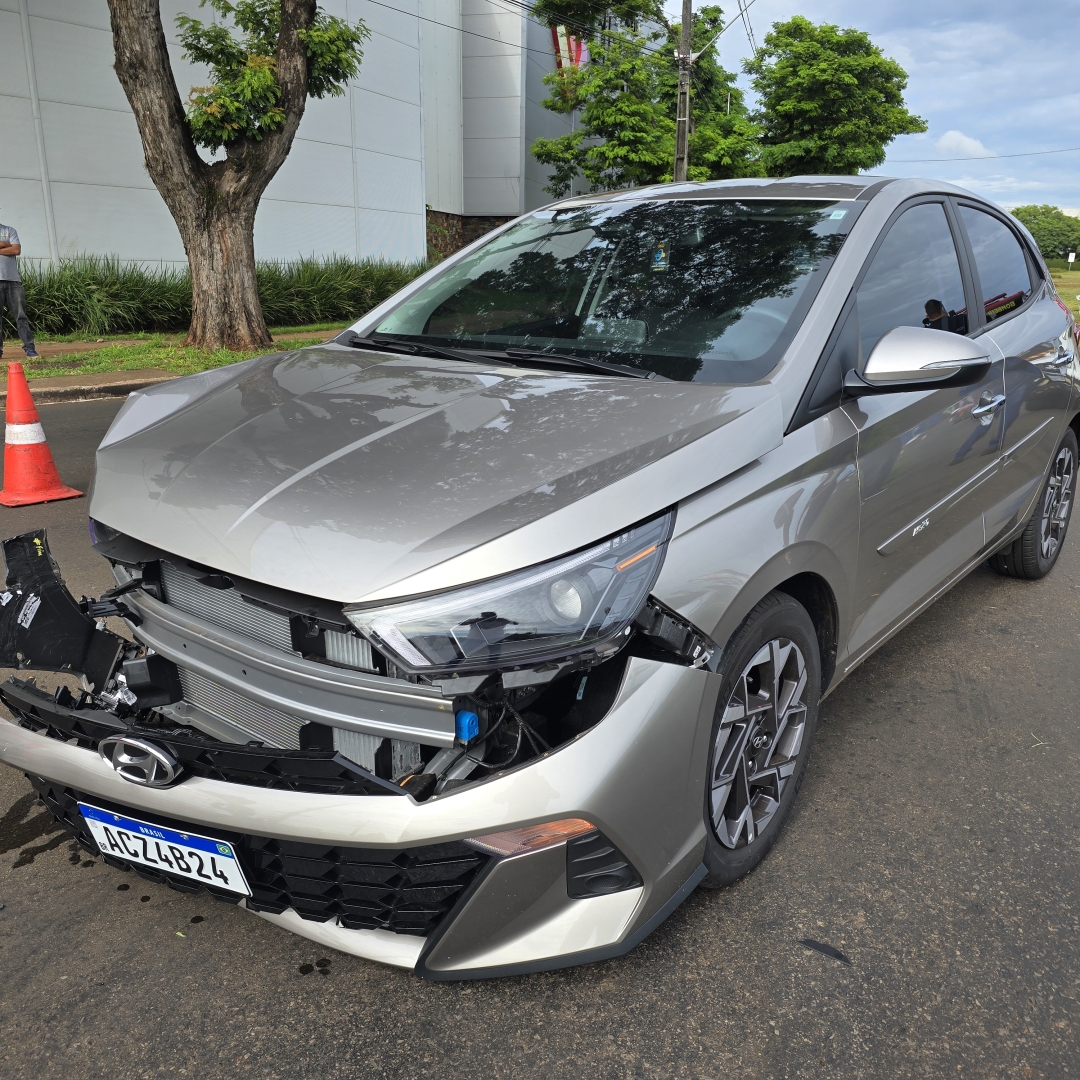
<box><xmin>420</xmin><ymin>0</ymin><xmax>464</xmax><ymax>215</ymax></box>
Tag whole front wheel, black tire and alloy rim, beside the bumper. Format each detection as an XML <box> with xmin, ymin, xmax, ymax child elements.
<box><xmin>702</xmin><ymin>592</ymin><xmax>821</xmax><ymax>888</ymax></box>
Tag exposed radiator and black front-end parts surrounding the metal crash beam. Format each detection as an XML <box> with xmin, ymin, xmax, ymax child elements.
<box><xmin>0</xmin><ymin>523</ymin><xmax>716</xmax><ymax>801</ymax></box>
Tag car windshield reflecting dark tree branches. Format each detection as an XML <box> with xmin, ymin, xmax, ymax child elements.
<box><xmin>374</xmin><ymin>200</ymin><xmax>860</xmax><ymax>382</ymax></box>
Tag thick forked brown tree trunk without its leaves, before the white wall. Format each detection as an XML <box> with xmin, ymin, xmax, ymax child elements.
<box><xmin>108</xmin><ymin>0</ymin><xmax>316</xmax><ymax>349</ymax></box>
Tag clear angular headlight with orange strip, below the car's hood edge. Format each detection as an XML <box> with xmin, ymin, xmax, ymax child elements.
<box><xmin>345</xmin><ymin>510</ymin><xmax>675</xmax><ymax>675</ymax></box>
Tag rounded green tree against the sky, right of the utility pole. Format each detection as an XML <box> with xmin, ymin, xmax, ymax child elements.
<box><xmin>743</xmin><ymin>15</ymin><xmax>927</xmax><ymax>176</ymax></box>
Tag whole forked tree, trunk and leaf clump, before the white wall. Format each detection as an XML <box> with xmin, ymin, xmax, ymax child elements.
<box><xmin>108</xmin><ymin>0</ymin><xmax>368</xmax><ymax>349</ymax></box>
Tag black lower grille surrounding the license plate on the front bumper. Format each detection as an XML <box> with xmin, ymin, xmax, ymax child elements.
<box><xmin>29</xmin><ymin>775</ymin><xmax>490</xmax><ymax>935</ymax></box>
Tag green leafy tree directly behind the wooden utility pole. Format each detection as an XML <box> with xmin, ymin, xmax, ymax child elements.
<box><xmin>532</xmin><ymin>3</ymin><xmax>760</xmax><ymax>199</ymax></box>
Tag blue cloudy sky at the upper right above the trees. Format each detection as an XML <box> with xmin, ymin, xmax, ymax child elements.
<box><xmin>665</xmin><ymin>0</ymin><xmax>1080</xmax><ymax>208</ymax></box>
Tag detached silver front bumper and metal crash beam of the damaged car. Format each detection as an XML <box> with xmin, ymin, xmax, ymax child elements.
<box><xmin>0</xmin><ymin>534</ymin><xmax>719</xmax><ymax>980</ymax></box>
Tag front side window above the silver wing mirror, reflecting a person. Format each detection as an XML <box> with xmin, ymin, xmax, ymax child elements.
<box><xmin>856</xmin><ymin>203</ymin><xmax>968</xmax><ymax>369</ymax></box>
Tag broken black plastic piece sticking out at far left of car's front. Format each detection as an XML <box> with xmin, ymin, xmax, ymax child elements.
<box><xmin>0</xmin><ymin>529</ymin><xmax>125</xmax><ymax>689</ymax></box>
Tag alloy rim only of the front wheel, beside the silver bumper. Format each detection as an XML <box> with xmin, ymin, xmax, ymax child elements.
<box><xmin>711</xmin><ymin>637</ymin><xmax>807</xmax><ymax>849</ymax></box>
